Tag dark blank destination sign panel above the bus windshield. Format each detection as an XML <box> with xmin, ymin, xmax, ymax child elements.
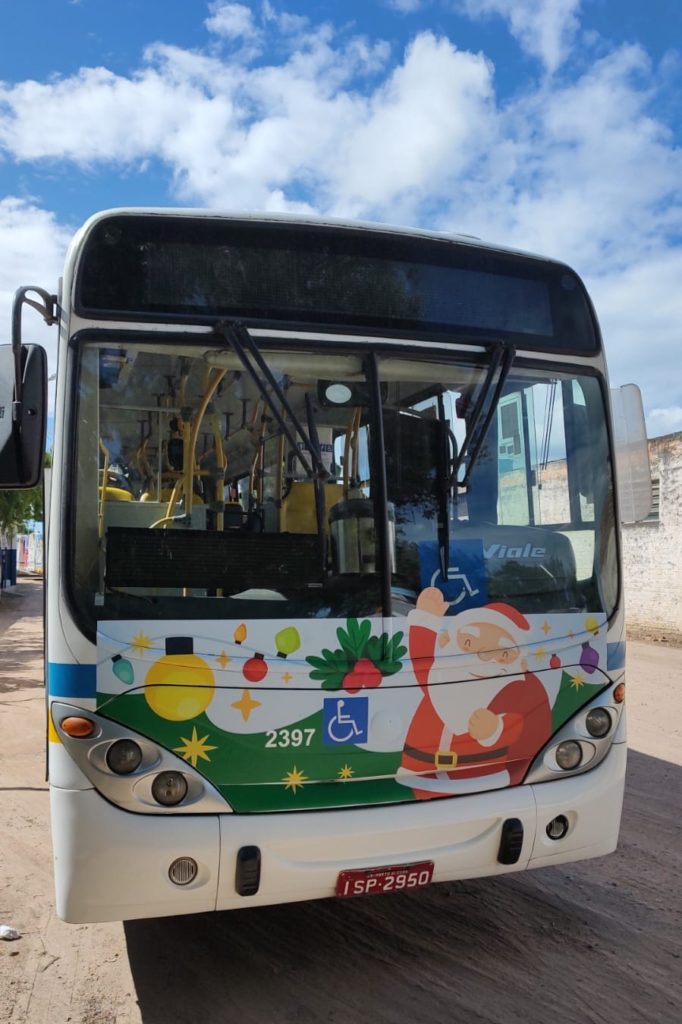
<box><xmin>76</xmin><ymin>214</ymin><xmax>599</xmax><ymax>353</ymax></box>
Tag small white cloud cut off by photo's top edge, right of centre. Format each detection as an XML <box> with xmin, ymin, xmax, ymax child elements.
<box><xmin>461</xmin><ymin>0</ymin><xmax>581</xmax><ymax>72</ymax></box>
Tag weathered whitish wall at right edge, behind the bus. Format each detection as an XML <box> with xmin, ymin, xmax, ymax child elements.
<box><xmin>623</xmin><ymin>432</ymin><xmax>682</xmax><ymax>642</ymax></box>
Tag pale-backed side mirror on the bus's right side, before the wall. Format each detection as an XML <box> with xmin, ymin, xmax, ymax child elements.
<box><xmin>611</xmin><ymin>384</ymin><xmax>651</xmax><ymax>523</ymax></box>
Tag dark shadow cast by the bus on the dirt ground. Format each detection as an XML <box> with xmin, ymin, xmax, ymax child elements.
<box><xmin>125</xmin><ymin>752</ymin><xmax>682</xmax><ymax>1024</ymax></box>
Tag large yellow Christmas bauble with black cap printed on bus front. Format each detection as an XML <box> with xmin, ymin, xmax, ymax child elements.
<box><xmin>144</xmin><ymin>637</ymin><xmax>215</xmax><ymax>722</ymax></box>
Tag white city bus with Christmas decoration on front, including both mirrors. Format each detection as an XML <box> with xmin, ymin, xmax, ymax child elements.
<box><xmin>0</xmin><ymin>209</ymin><xmax>648</xmax><ymax>923</ymax></box>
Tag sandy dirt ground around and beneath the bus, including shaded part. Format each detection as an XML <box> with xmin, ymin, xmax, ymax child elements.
<box><xmin>0</xmin><ymin>581</ymin><xmax>682</xmax><ymax>1024</ymax></box>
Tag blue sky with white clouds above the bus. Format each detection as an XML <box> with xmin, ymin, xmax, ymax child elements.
<box><xmin>0</xmin><ymin>0</ymin><xmax>682</xmax><ymax>436</ymax></box>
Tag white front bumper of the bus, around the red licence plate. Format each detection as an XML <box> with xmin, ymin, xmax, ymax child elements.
<box><xmin>51</xmin><ymin>743</ymin><xmax>627</xmax><ymax>923</ymax></box>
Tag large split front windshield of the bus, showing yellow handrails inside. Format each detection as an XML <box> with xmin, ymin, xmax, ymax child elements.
<box><xmin>69</xmin><ymin>332</ymin><xmax>617</xmax><ymax>634</ymax></box>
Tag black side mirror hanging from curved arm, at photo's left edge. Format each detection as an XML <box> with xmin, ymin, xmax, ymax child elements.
<box><xmin>0</xmin><ymin>345</ymin><xmax>47</xmax><ymax>489</ymax></box>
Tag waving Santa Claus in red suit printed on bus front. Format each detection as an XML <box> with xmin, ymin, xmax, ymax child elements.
<box><xmin>396</xmin><ymin>587</ymin><xmax>552</xmax><ymax>800</ymax></box>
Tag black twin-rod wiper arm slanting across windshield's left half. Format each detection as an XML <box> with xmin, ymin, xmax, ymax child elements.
<box><xmin>213</xmin><ymin>321</ymin><xmax>329</xmax><ymax>480</ymax></box>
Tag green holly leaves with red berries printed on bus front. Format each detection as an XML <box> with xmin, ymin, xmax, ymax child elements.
<box><xmin>306</xmin><ymin>618</ymin><xmax>408</xmax><ymax>693</ymax></box>
